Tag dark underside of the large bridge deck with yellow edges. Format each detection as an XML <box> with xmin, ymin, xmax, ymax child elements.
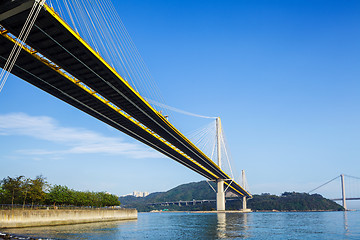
<box><xmin>0</xmin><ymin>1</ymin><xmax>251</xmax><ymax>196</ymax></box>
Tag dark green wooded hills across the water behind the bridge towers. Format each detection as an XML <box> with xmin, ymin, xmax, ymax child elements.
<box><xmin>119</xmin><ymin>181</ymin><xmax>343</xmax><ymax>212</ymax></box>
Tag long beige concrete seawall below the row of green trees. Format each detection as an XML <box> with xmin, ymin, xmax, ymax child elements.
<box><xmin>0</xmin><ymin>209</ymin><xmax>137</xmax><ymax>229</ymax></box>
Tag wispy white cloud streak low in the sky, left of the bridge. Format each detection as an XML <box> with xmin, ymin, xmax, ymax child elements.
<box><xmin>0</xmin><ymin>113</ymin><xmax>162</xmax><ymax>158</ymax></box>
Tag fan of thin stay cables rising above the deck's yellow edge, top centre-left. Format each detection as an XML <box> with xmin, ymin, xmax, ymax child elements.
<box><xmin>50</xmin><ymin>0</ymin><xmax>169</xmax><ymax>119</ymax></box>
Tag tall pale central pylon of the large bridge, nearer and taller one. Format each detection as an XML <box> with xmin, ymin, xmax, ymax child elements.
<box><xmin>216</xmin><ymin>117</ymin><xmax>225</xmax><ymax>211</ymax></box>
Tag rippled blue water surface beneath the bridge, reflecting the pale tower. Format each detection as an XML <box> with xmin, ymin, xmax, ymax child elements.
<box><xmin>2</xmin><ymin>212</ymin><xmax>360</xmax><ymax>240</ymax></box>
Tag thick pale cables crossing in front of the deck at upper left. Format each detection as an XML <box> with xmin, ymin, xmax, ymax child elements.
<box><xmin>0</xmin><ymin>0</ymin><xmax>45</xmax><ymax>92</ymax></box>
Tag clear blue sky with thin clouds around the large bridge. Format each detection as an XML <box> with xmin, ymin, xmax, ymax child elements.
<box><xmin>0</xmin><ymin>0</ymin><xmax>360</xmax><ymax>205</ymax></box>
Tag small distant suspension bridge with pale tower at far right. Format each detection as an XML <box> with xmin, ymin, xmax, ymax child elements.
<box><xmin>309</xmin><ymin>174</ymin><xmax>360</xmax><ymax>210</ymax></box>
